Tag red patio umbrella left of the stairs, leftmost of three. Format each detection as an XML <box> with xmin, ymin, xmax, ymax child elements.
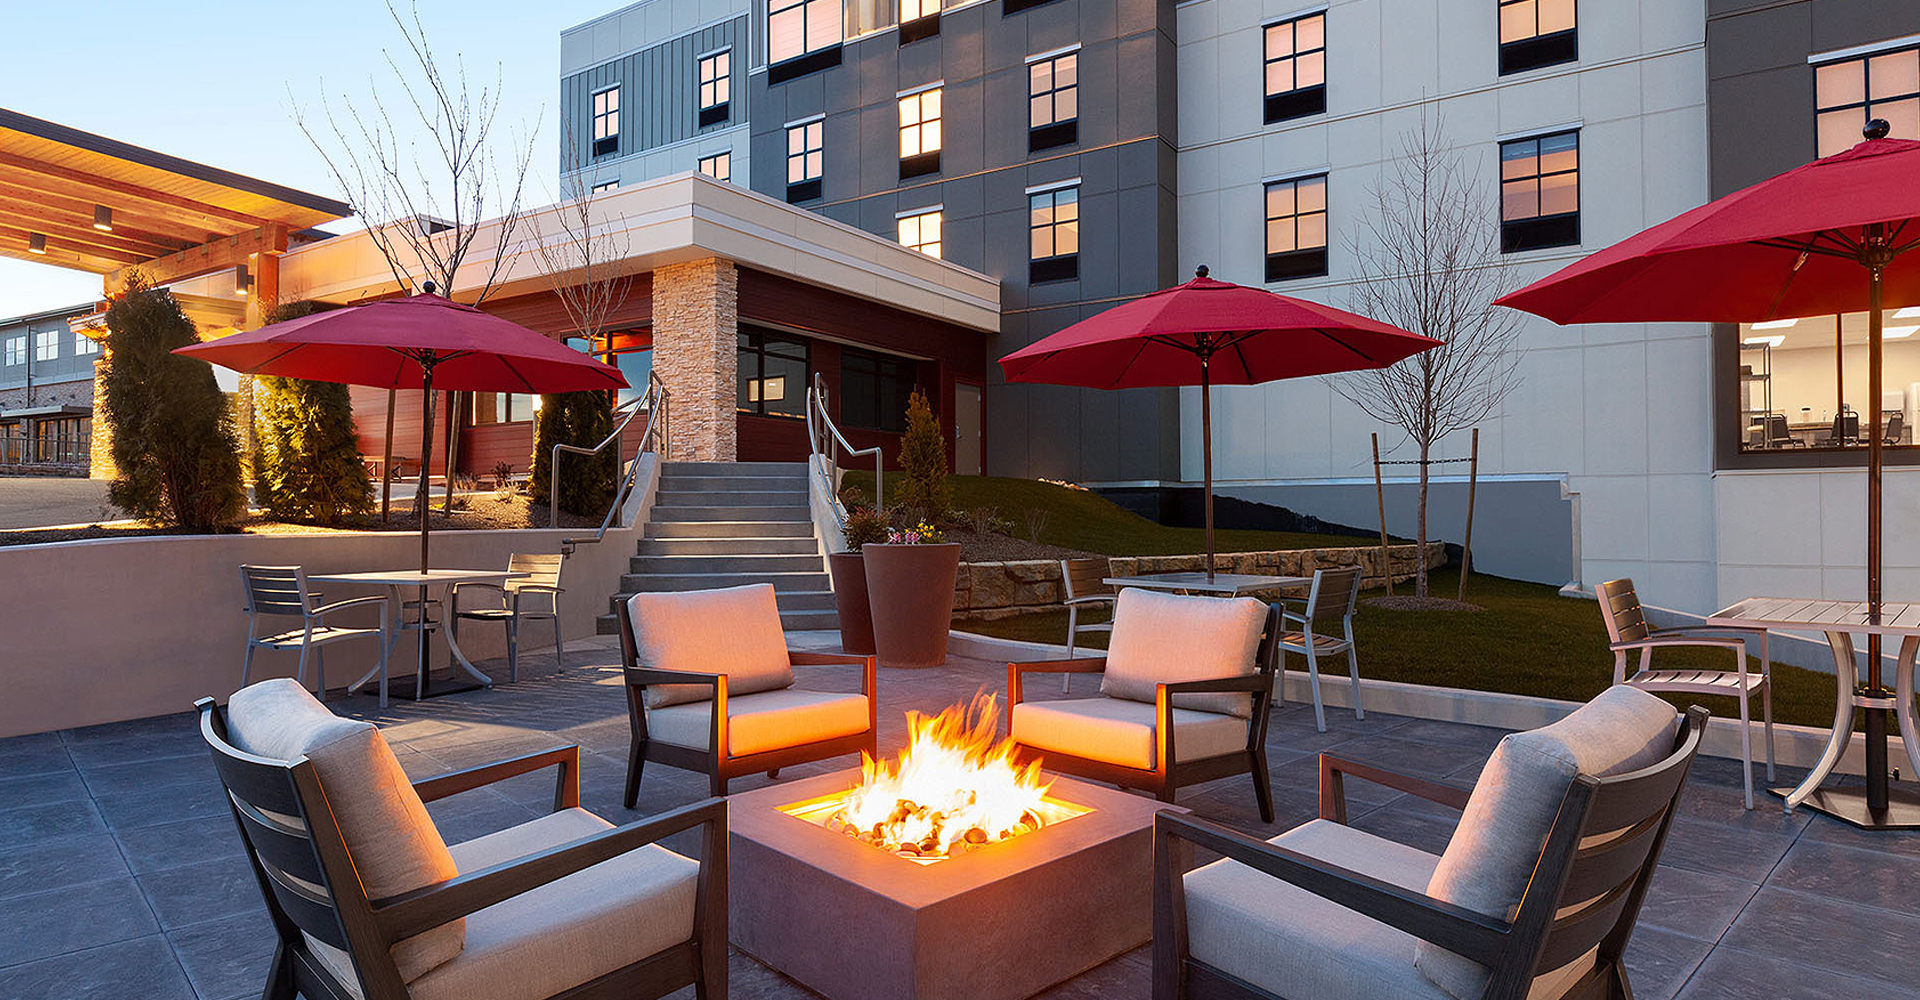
<box><xmin>175</xmin><ymin>282</ymin><xmax>626</xmax><ymax>572</ymax></box>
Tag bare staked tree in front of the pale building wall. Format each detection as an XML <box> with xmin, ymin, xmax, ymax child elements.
<box><xmin>1332</xmin><ymin>111</ymin><xmax>1521</xmax><ymax>597</ymax></box>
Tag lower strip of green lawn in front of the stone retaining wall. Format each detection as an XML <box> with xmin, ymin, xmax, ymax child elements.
<box><xmin>956</xmin><ymin>566</ymin><xmax>1834</xmax><ymax>725</ymax></box>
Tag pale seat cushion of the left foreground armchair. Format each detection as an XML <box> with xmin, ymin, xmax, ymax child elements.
<box><xmin>315</xmin><ymin>808</ymin><xmax>699</xmax><ymax>1000</ymax></box>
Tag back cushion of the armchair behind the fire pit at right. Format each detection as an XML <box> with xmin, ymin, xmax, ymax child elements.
<box><xmin>1100</xmin><ymin>587</ymin><xmax>1267</xmax><ymax>718</ymax></box>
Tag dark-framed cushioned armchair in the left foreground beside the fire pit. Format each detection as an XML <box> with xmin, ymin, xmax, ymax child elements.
<box><xmin>196</xmin><ymin>679</ymin><xmax>728</xmax><ymax>1000</ymax></box>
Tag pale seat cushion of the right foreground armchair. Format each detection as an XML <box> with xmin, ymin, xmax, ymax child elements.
<box><xmin>1185</xmin><ymin>820</ymin><xmax>1594</xmax><ymax>1000</ymax></box>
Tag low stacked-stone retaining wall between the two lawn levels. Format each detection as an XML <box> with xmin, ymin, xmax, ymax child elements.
<box><xmin>954</xmin><ymin>541</ymin><xmax>1446</xmax><ymax>618</ymax></box>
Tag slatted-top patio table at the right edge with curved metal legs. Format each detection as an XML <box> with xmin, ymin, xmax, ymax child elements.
<box><xmin>1707</xmin><ymin>597</ymin><xmax>1920</xmax><ymax>827</ymax></box>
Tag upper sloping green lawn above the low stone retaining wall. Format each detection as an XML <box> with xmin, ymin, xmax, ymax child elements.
<box><xmin>843</xmin><ymin>472</ymin><xmax>1367</xmax><ymax>555</ymax></box>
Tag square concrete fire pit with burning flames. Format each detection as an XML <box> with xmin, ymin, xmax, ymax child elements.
<box><xmin>728</xmin><ymin>701</ymin><xmax>1185</xmax><ymax>1000</ymax></box>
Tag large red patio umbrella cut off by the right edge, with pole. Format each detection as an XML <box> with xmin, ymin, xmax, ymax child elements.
<box><xmin>1498</xmin><ymin>119</ymin><xmax>1920</xmax><ymax>812</ymax></box>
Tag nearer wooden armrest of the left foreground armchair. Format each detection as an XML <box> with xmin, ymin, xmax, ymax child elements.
<box><xmin>372</xmin><ymin>798</ymin><xmax>726</xmax><ymax>940</ymax></box>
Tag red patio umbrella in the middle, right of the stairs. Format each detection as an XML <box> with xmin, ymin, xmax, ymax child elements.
<box><xmin>1000</xmin><ymin>265</ymin><xmax>1442</xmax><ymax>580</ymax></box>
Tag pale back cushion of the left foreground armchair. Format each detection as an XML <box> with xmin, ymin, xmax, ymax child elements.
<box><xmin>227</xmin><ymin>678</ymin><xmax>467</xmax><ymax>981</ymax></box>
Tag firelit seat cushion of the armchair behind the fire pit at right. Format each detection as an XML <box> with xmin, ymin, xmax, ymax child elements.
<box><xmin>1014</xmin><ymin>699</ymin><xmax>1246</xmax><ymax>770</ymax></box>
